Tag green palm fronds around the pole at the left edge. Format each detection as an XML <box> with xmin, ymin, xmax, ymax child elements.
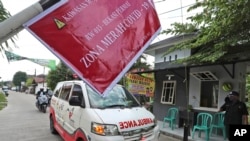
<box><xmin>0</xmin><ymin>0</ymin><xmax>15</xmax><ymax>52</ymax></box>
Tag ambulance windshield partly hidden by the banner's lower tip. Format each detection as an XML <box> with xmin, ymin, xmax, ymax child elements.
<box><xmin>87</xmin><ymin>85</ymin><xmax>140</xmax><ymax>109</ymax></box>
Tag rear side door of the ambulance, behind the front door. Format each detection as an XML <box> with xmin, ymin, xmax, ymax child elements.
<box><xmin>57</xmin><ymin>82</ymin><xmax>73</xmax><ymax>128</ymax></box>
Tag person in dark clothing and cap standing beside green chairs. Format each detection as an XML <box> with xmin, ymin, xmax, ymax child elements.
<box><xmin>221</xmin><ymin>91</ymin><xmax>248</xmax><ymax>140</ymax></box>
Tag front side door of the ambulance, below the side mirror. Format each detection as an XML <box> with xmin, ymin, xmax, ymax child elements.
<box><xmin>64</xmin><ymin>83</ymin><xmax>84</xmax><ymax>134</ymax></box>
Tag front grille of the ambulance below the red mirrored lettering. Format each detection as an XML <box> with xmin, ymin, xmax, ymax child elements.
<box><xmin>121</xmin><ymin>126</ymin><xmax>155</xmax><ymax>141</ymax></box>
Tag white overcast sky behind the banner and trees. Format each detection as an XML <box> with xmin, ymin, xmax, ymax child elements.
<box><xmin>0</xmin><ymin>0</ymin><xmax>199</xmax><ymax>80</ymax></box>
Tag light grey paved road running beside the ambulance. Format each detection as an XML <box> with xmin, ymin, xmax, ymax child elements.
<box><xmin>0</xmin><ymin>91</ymin><xmax>178</xmax><ymax>141</ymax></box>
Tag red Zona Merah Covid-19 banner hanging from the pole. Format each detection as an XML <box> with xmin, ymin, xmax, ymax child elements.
<box><xmin>25</xmin><ymin>0</ymin><xmax>161</xmax><ymax>96</ymax></box>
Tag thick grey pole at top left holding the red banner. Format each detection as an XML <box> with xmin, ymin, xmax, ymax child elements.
<box><xmin>0</xmin><ymin>0</ymin><xmax>60</xmax><ymax>44</ymax></box>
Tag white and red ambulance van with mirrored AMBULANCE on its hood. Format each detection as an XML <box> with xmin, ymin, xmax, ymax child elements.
<box><xmin>50</xmin><ymin>80</ymin><xmax>159</xmax><ymax>141</ymax></box>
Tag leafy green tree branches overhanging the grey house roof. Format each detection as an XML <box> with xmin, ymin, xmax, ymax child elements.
<box><xmin>162</xmin><ymin>0</ymin><xmax>250</xmax><ymax>63</ymax></box>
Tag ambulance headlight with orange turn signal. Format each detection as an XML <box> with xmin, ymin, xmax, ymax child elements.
<box><xmin>91</xmin><ymin>122</ymin><xmax>119</xmax><ymax>136</ymax></box>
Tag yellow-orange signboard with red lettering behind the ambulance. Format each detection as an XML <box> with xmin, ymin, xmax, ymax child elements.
<box><xmin>126</xmin><ymin>74</ymin><xmax>155</xmax><ymax>97</ymax></box>
